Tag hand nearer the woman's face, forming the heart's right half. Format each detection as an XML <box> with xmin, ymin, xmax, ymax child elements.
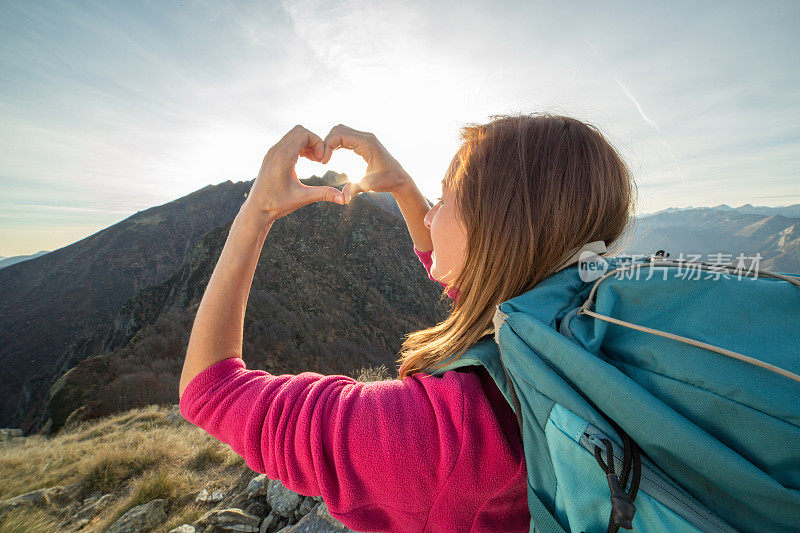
<box><xmin>322</xmin><ymin>124</ymin><xmax>411</xmax><ymax>202</ymax></box>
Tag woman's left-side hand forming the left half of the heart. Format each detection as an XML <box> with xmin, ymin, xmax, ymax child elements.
<box><xmin>242</xmin><ymin>125</ymin><xmax>345</xmax><ymax>223</ymax></box>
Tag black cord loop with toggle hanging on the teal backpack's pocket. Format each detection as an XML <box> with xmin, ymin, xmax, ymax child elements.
<box><xmin>594</xmin><ymin>419</ymin><xmax>642</xmax><ymax>533</ymax></box>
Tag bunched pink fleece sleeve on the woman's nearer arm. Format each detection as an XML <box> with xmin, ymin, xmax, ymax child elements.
<box><xmin>180</xmin><ymin>357</ymin><xmax>464</xmax><ymax>531</ymax></box>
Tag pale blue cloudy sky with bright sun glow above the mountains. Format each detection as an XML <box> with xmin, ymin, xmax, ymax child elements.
<box><xmin>0</xmin><ymin>0</ymin><xmax>800</xmax><ymax>257</ymax></box>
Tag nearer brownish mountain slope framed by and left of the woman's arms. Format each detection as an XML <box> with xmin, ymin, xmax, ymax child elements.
<box><xmin>28</xmin><ymin>178</ymin><xmax>446</xmax><ymax>433</ymax></box>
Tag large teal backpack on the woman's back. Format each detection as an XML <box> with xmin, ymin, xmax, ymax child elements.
<box><xmin>434</xmin><ymin>241</ymin><xmax>800</xmax><ymax>533</ymax></box>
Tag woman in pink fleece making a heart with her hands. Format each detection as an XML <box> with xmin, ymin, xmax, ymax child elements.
<box><xmin>179</xmin><ymin>114</ymin><xmax>634</xmax><ymax>532</ymax></box>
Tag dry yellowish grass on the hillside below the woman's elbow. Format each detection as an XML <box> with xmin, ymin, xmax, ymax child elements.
<box><xmin>0</xmin><ymin>406</ymin><xmax>247</xmax><ymax>532</ymax></box>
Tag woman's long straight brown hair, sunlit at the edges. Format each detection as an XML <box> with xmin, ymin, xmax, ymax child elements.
<box><xmin>397</xmin><ymin>113</ymin><xmax>636</xmax><ymax>379</ymax></box>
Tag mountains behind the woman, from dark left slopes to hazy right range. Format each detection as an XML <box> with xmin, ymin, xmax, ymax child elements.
<box><xmin>0</xmin><ymin>183</ymin><xmax>800</xmax><ymax>433</ymax></box>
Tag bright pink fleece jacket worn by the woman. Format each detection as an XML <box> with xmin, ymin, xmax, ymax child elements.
<box><xmin>180</xmin><ymin>248</ymin><xmax>530</xmax><ymax>532</ymax></box>
